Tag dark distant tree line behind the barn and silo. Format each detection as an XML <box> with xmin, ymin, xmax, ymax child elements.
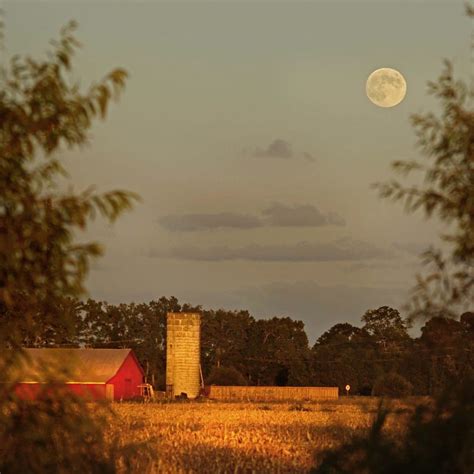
<box><xmin>6</xmin><ymin>297</ymin><xmax>474</xmax><ymax>395</ymax></box>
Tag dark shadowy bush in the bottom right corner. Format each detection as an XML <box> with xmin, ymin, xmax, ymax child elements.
<box><xmin>311</xmin><ymin>380</ymin><xmax>474</xmax><ymax>474</ymax></box>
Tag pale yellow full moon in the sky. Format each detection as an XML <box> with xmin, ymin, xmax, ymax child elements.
<box><xmin>365</xmin><ymin>67</ymin><xmax>407</xmax><ymax>107</ymax></box>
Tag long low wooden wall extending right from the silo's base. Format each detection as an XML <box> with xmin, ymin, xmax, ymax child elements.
<box><xmin>206</xmin><ymin>385</ymin><xmax>339</xmax><ymax>401</ymax></box>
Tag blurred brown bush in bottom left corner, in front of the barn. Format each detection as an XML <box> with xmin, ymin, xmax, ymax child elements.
<box><xmin>0</xmin><ymin>387</ymin><xmax>116</xmax><ymax>473</ymax></box>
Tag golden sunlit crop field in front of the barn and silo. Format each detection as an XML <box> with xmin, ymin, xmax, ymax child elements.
<box><xmin>111</xmin><ymin>398</ymin><xmax>420</xmax><ymax>473</ymax></box>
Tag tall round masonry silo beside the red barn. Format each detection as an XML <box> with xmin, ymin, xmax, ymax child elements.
<box><xmin>166</xmin><ymin>313</ymin><xmax>201</xmax><ymax>398</ymax></box>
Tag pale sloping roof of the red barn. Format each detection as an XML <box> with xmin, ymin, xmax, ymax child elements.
<box><xmin>3</xmin><ymin>348</ymin><xmax>141</xmax><ymax>383</ymax></box>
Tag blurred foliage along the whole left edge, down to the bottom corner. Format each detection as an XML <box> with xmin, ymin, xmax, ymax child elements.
<box><xmin>0</xmin><ymin>22</ymin><xmax>137</xmax><ymax>472</ymax></box>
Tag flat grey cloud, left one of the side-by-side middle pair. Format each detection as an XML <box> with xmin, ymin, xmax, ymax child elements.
<box><xmin>159</xmin><ymin>212</ymin><xmax>262</xmax><ymax>232</ymax></box>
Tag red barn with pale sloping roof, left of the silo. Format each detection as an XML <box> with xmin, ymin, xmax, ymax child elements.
<box><xmin>4</xmin><ymin>349</ymin><xmax>144</xmax><ymax>400</ymax></box>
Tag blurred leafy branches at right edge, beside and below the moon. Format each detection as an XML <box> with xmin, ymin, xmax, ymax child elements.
<box><xmin>375</xmin><ymin>64</ymin><xmax>474</xmax><ymax>319</ymax></box>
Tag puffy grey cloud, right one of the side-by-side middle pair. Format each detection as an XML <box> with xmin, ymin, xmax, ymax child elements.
<box><xmin>262</xmin><ymin>203</ymin><xmax>345</xmax><ymax>227</ymax></box>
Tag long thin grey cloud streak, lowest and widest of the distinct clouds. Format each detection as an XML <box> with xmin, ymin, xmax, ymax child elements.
<box><xmin>167</xmin><ymin>239</ymin><xmax>391</xmax><ymax>262</ymax></box>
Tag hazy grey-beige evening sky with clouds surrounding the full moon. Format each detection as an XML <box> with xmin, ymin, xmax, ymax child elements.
<box><xmin>3</xmin><ymin>0</ymin><xmax>471</xmax><ymax>343</ymax></box>
